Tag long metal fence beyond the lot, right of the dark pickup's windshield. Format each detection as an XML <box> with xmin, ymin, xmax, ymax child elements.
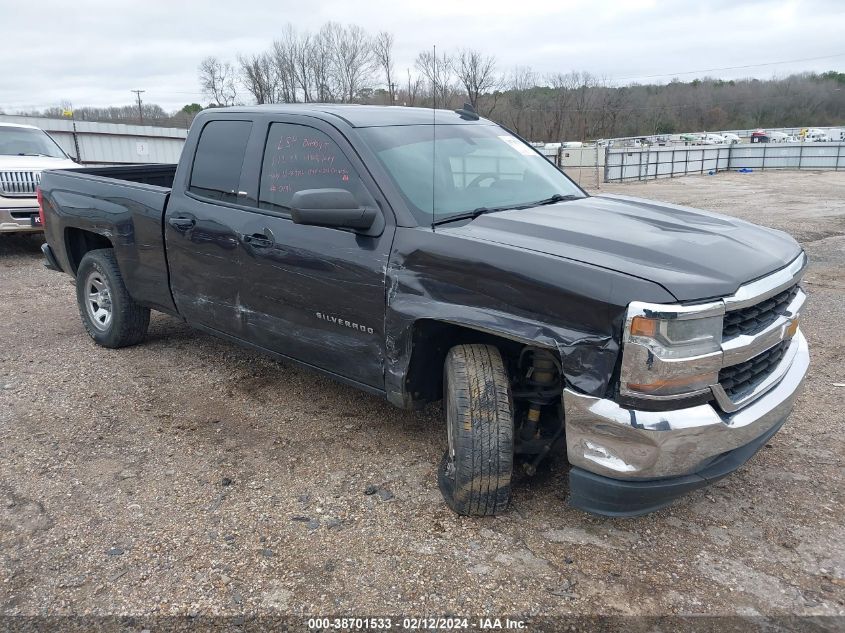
<box><xmin>604</xmin><ymin>143</ymin><xmax>845</xmax><ymax>182</ymax></box>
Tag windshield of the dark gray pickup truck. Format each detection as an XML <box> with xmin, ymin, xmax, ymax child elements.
<box><xmin>359</xmin><ymin>124</ymin><xmax>584</xmax><ymax>224</ymax></box>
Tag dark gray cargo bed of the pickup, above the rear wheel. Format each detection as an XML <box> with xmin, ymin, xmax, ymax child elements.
<box><xmin>40</xmin><ymin>165</ymin><xmax>176</xmax><ymax>313</ymax></box>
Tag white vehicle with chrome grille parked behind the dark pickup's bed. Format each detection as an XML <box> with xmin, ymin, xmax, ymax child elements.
<box><xmin>0</xmin><ymin>123</ymin><xmax>77</xmax><ymax>233</ymax></box>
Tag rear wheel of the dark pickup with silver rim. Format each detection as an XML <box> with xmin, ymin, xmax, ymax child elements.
<box><xmin>76</xmin><ymin>248</ymin><xmax>150</xmax><ymax>348</ymax></box>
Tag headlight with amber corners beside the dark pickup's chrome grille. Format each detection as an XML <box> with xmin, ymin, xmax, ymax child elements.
<box><xmin>620</xmin><ymin>301</ymin><xmax>725</xmax><ymax>399</ymax></box>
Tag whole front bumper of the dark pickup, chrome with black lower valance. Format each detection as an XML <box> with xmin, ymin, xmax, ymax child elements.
<box><xmin>563</xmin><ymin>330</ymin><xmax>810</xmax><ymax>516</ymax></box>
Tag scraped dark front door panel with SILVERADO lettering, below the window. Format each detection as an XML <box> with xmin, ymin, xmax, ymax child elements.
<box><xmin>234</xmin><ymin>213</ymin><xmax>393</xmax><ymax>389</ymax></box>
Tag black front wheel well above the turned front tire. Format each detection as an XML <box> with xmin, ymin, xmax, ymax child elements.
<box><xmin>405</xmin><ymin>319</ymin><xmax>525</xmax><ymax>402</ymax></box>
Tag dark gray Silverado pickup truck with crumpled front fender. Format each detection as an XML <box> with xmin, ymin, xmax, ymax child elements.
<box><xmin>39</xmin><ymin>105</ymin><xmax>809</xmax><ymax>515</ymax></box>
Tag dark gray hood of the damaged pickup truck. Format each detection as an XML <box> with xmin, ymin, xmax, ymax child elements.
<box><xmin>443</xmin><ymin>195</ymin><xmax>801</xmax><ymax>301</ymax></box>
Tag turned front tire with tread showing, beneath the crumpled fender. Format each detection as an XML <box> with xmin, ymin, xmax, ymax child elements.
<box><xmin>437</xmin><ymin>345</ymin><xmax>514</xmax><ymax>516</ymax></box>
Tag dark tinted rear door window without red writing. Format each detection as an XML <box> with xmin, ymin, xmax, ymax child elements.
<box><xmin>188</xmin><ymin>121</ymin><xmax>252</xmax><ymax>202</ymax></box>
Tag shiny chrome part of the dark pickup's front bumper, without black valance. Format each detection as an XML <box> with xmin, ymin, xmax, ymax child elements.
<box><xmin>563</xmin><ymin>330</ymin><xmax>810</xmax><ymax>480</ymax></box>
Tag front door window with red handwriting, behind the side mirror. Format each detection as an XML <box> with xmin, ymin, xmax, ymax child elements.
<box><xmin>258</xmin><ymin>123</ymin><xmax>375</xmax><ymax>212</ymax></box>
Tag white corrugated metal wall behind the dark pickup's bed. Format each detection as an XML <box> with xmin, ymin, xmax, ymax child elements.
<box><xmin>0</xmin><ymin>115</ymin><xmax>188</xmax><ymax>165</ymax></box>
